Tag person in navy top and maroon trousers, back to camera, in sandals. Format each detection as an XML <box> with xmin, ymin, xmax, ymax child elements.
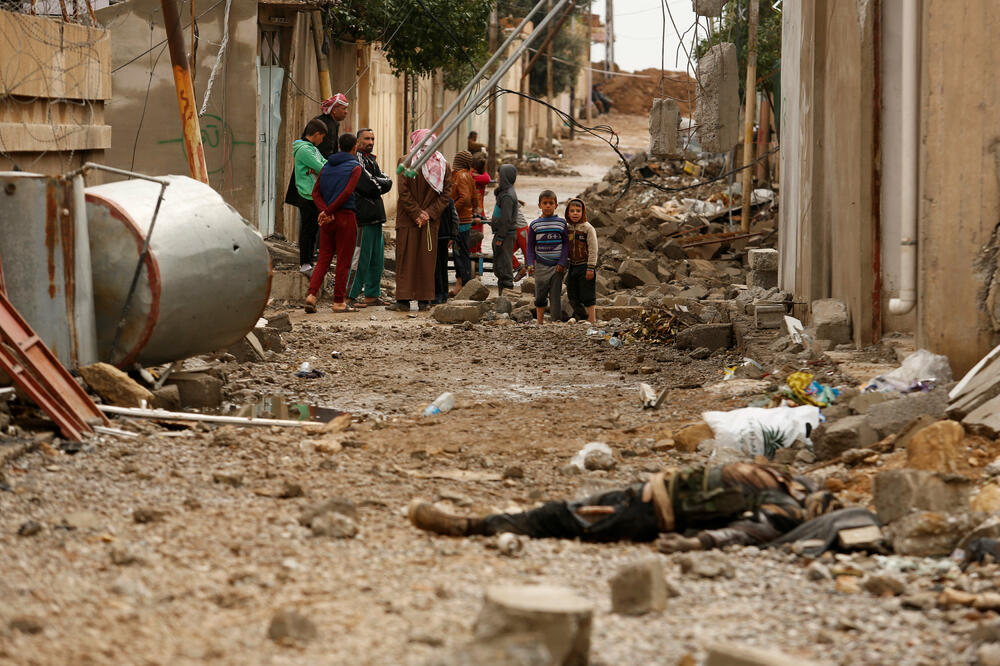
<box><xmin>306</xmin><ymin>134</ymin><xmax>364</xmax><ymax>312</ymax></box>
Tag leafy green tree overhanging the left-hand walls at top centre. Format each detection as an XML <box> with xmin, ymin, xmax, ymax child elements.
<box><xmin>325</xmin><ymin>0</ymin><xmax>493</xmax><ymax>85</ymax></box>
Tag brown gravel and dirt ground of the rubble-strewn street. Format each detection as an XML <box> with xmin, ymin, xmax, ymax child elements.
<box><xmin>0</xmin><ymin>116</ymin><xmax>991</xmax><ymax>666</ymax></box>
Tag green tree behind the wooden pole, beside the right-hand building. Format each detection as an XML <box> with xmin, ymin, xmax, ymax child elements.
<box><xmin>695</xmin><ymin>0</ymin><xmax>781</xmax><ymax>97</ymax></box>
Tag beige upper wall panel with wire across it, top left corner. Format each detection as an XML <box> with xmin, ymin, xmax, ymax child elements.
<box><xmin>0</xmin><ymin>10</ymin><xmax>111</xmax><ymax>100</ymax></box>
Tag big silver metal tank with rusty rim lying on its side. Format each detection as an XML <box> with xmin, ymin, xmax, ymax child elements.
<box><xmin>86</xmin><ymin>176</ymin><xmax>271</xmax><ymax>366</ymax></box>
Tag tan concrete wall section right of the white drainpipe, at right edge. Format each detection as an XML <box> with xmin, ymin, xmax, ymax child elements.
<box><xmin>917</xmin><ymin>0</ymin><xmax>1000</xmax><ymax>373</ymax></box>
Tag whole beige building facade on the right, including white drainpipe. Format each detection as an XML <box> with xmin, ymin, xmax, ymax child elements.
<box><xmin>780</xmin><ymin>0</ymin><xmax>1000</xmax><ymax>374</ymax></box>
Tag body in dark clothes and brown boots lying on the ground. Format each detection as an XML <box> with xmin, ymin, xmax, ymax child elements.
<box><xmin>409</xmin><ymin>463</ymin><xmax>872</xmax><ymax>552</ymax></box>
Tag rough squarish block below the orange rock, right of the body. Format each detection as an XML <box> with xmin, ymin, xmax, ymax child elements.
<box><xmin>872</xmin><ymin>469</ymin><xmax>972</xmax><ymax>524</ymax></box>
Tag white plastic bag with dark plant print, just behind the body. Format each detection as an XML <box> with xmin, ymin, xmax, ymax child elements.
<box><xmin>701</xmin><ymin>405</ymin><xmax>822</xmax><ymax>458</ymax></box>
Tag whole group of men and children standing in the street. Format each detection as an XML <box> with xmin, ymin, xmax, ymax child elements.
<box><xmin>285</xmin><ymin>93</ymin><xmax>597</xmax><ymax>323</ymax></box>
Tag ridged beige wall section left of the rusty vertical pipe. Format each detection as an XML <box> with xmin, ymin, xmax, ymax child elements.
<box><xmin>779</xmin><ymin>0</ymin><xmax>878</xmax><ymax>344</ymax></box>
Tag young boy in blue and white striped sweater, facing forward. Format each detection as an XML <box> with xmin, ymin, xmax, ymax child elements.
<box><xmin>524</xmin><ymin>190</ymin><xmax>569</xmax><ymax>324</ymax></box>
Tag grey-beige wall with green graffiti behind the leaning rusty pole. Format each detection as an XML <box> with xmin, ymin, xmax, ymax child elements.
<box><xmin>98</xmin><ymin>0</ymin><xmax>257</xmax><ymax>224</ymax></box>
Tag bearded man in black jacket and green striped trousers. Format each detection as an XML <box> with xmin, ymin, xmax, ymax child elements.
<box><xmin>347</xmin><ymin>128</ymin><xmax>392</xmax><ymax>307</ymax></box>
